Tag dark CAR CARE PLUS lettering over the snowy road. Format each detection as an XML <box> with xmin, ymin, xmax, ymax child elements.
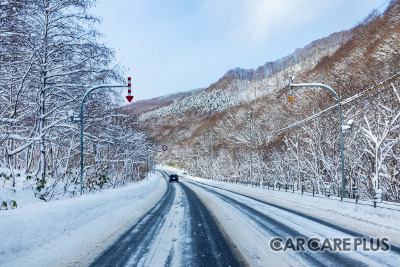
<box><xmin>269</xmin><ymin>237</ymin><xmax>390</xmax><ymax>252</ymax></box>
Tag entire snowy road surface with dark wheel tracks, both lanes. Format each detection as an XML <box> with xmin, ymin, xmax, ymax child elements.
<box><xmin>92</xmin><ymin>172</ymin><xmax>400</xmax><ymax>266</ymax></box>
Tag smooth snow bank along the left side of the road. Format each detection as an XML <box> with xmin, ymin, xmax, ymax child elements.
<box><xmin>0</xmin><ymin>174</ymin><xmax>166</xmax><ymax>266</ymax></box>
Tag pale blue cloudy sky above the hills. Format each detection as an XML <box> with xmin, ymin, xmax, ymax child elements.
<box><xmin>92</xmin><ymin>0</ymin><xmax>388</xmax><ymax>101</ymax></box>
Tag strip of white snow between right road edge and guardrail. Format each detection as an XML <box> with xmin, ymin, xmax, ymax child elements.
<box><xmin>163</xmin><ymin>167</ymin><xmax>400</xmax><ymax>245</ymax></box>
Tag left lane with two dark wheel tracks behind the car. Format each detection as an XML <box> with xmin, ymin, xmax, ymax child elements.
<box><xmin>91</xmin><ymin>173</ymin><xmax>243</xmax><ymax>266</ymax></box>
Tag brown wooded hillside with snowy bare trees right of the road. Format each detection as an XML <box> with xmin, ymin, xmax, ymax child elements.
<box><xmin>134</xmin><ymin>1</ymin><xmax>400</xmax><ymax>201</ymax></box>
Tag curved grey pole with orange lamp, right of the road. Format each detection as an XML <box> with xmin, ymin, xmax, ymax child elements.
<box><xmin>289</xmin><ymin>77</ymin><xmax>346</xmax><ymax>200</ymax></box>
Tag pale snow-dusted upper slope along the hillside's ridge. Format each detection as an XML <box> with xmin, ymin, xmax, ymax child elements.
<box><xmin>139</xmin><ymin>31</ymin><xmax>347</xmax><ymax>121</ymax></box>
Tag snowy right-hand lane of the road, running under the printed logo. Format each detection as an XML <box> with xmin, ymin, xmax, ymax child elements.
<box><xmin>182</xmin><ymin>179</ymin><xmax>399</xmax><ymax>266</ymax></box>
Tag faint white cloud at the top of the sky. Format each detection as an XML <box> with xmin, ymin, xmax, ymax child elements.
<box><xmin>203</xmin><ymin>0</ymin><xmax>330</xmax><ymax>44</ymax></box>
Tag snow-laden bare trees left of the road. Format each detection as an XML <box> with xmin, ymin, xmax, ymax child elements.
<box><xmin>0</xmin><ymin>0</ymin><xmax>151</xmax><ymax>201</ymax></box>
